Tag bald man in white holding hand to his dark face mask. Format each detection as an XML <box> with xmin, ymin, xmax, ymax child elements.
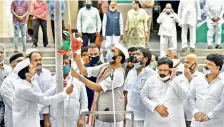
<box><xmin>174</xmin><ymin>54</ymin><xmax>203</xmax><ymax>127</ymax></box>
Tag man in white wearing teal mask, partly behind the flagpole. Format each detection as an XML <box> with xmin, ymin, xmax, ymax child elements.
<box><xmin>50</xmin><ymin>56</ymin><xmax>88</xmax><ymax>127</ymax></box>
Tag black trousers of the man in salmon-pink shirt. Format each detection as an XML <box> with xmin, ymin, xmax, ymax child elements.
<box><xmin>33</xmin><ymin>19</ymin><xmax>48</xmax><ymax>46</ymax></box>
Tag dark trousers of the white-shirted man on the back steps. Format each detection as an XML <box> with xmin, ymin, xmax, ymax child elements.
<box><xmin>82</xmin><ymin>33</ymin><xmax>96</xmax><ymax>47</ymax></box>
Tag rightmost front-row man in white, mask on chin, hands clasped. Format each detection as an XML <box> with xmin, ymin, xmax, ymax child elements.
<box><xmin>188</xmin><ymin>54</ymin><xmax>224</xmax><ymax>127</ymax></box>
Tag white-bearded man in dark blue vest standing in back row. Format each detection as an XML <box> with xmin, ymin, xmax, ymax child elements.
<box><xmin>102</xmin><ymin>1</ymin><xmax>124</xmax><ymax>51</ymax></box>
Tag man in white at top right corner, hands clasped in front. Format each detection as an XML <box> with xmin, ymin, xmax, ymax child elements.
<box><xmin>205</xmin><ymin>0</ymin><xmax>224</xmax><ymax>49</ymax></box>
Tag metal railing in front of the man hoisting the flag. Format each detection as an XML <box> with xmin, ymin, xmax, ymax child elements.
<box><xmin>81</xmin><ymin>111</ymin><xmax>134</xmax><ymax>127</ymax></box>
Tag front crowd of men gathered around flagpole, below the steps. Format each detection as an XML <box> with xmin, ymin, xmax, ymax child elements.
<box><xmin>0</xmin><ymin>43</ymin><xmax>224</xmax><ymax>127</ymax></box>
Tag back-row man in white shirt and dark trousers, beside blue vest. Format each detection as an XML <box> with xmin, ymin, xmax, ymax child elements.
<box><xmin>77</xmin><ymin>0</ymin><xmax>101</xmax><ymax>47</ymax></box>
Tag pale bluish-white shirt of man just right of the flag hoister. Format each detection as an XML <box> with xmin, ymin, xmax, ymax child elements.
<box><xmin>124</xmin><ymin>66</ymin><xmax>156</xmax><ymax>127</ymax></box>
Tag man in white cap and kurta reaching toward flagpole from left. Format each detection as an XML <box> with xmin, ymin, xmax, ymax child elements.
<box><xmin>12</xmin><ymin>59</ymin><xmax>73</xmax><ymax>127</ymax></box>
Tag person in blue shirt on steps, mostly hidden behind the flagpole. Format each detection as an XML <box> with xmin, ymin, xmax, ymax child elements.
<box><xmin>49</xmin><ymin>0</ymin><xmax>66</xmax><ymax>42</ymax></box>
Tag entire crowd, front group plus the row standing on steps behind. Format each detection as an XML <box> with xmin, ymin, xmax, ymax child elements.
<box><xmin>3</xmin><ymin>0</ymin><xmax>224</xmax><ymax>127</ymax></box>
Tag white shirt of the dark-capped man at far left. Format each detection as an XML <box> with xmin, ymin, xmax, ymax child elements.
<box><xmin>1</xmin><ymin>72</ymin><xmax>20</xmax><ymax>127</ymax></box>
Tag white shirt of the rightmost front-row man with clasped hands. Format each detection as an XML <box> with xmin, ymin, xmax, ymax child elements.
<box><xmin>188</xmin><ymin>73</ymin><xmax>224</xmax><ymax>127</ymax></box>
